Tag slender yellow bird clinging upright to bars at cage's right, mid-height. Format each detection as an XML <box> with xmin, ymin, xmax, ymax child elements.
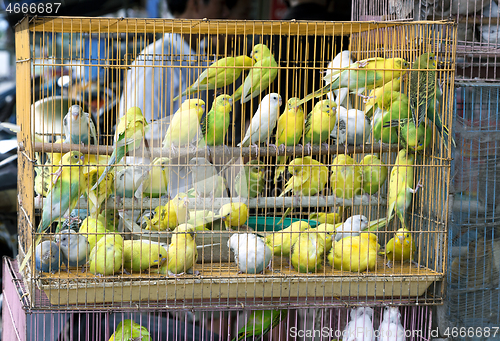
<box><xmin>387</xmin><ymin>149</ymin><xmax>422</xmax><ymax>227</ymax></box>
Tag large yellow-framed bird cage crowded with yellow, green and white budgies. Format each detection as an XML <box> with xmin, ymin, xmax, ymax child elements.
<box><xmin>16</xmin><ymin>17</ymin><xmax>455</xmax><ymax>310</ymax></box>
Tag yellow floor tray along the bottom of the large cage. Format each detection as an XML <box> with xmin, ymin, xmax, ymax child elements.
<box><xmin>27</xmin><ymin>257</ymin><xmax>443</xmax><ymax>305</ymax></box>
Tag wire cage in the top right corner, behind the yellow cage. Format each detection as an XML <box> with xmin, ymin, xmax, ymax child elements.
<box><xmin>351</xmin><ymin>0</ymin><xmax>500</xmax><ymax>81</ymax></box>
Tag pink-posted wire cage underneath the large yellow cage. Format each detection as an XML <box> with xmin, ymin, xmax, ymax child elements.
<box><xmin>2</xmin><ymin>259</ymin><xmax>437</xmax><ymax>341</ymax></box>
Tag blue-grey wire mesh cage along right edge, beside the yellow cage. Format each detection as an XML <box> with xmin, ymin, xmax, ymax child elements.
<box><xmin>447</xmin><ymin>81</ymin><xmax>500</xmax><ymax>339</ymax></box>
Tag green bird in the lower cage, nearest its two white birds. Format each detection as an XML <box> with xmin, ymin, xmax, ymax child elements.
<box><xmin>232</xmin><ymin>310</ymin><xmax>287</xmax><ymax>341</ymax></box>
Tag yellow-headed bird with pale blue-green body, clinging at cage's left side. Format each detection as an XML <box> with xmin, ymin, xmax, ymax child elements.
<box><xmin>37</xmin><ymin>151</ymin><xmax>84</xmax><ymax>234</ymax></box>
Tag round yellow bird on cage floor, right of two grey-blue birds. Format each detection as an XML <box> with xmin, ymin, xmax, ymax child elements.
<box><xmin>89</xmin><ymin>234</ymin><xmax>123</xmax><ymax>276</ymax></box>
